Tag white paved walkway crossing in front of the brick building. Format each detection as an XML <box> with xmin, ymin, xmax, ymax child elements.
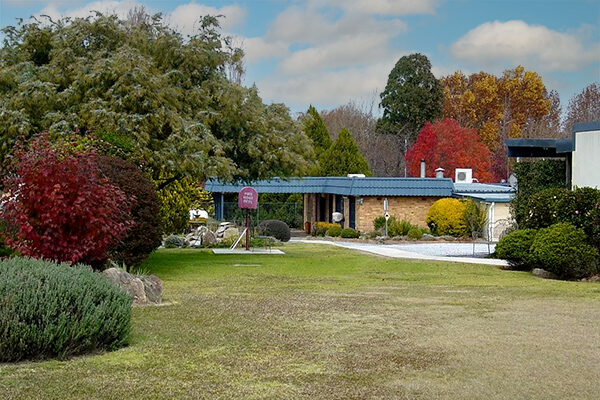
<box><xmin>292</xmin><ymin>239</ymin><xmax>508</xmax><ymax>266</ymax></box>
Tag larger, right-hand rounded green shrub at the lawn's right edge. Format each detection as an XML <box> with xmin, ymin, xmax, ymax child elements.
<box><xmin>531</xmin><ymin>222</ymin><xmax>598</xmax><ymax>279</ymax></box>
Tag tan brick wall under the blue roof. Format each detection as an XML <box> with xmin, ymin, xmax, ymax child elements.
<box><xmin>356</xmin><ymin>197</ymin><xmax>440</xmax><ymax>232</ymax></box>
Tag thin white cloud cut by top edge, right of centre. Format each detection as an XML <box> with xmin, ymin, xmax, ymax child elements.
<box><xmin>311</xmin><ymin>0</ymin><xmax>438</xmax><ymax>16</ymax></box>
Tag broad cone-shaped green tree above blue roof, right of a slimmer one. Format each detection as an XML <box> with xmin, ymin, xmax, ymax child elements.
<box><xmin>319</xmin><ymin>129</ymin><xmax>371</xmax><ymax>176</ymax></box>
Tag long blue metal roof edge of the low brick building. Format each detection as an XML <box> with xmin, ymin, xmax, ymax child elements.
<box><xmin>205</xmin><ymin>177</ymin><xmax>453</xmax><ymax>197</ymax></box>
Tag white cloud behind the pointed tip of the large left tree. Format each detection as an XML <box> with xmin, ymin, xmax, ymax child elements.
<box><xmin>167</xmin><ymin>3</ymin><xmax>246</xmax><ymax>35</ymax></box>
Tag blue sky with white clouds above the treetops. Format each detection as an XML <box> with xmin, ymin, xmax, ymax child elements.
<box><xmin>0</xmin><ymin>0</ymin><xmax>600</xmax><ymax>113</ymax></box>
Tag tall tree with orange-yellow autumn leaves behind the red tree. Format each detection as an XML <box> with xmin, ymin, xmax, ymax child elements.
<box><xmin>440</xmin><ymin>66</ymin><xmax>560</xmax><ymax>181</ymax></box>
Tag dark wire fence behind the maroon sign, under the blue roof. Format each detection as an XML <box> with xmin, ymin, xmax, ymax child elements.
<box><xmin>223</xmin><ymin>202</ymin><xmax>303</xmax><ymax>228</ymax></box>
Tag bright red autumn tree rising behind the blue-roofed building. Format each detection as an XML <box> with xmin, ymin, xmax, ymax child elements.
<box><xmin>406</xmin><ymin>118</ymin><xmax>492</xmax><ymax>182</ymax></box>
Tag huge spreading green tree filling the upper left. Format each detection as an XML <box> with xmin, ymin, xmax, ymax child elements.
<box><xmin>0</xmin><ymin>14</ymin><xmax>312</xmax><ymax>188</ymax></box>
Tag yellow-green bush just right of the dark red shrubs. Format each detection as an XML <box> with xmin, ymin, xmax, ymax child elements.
<box><xmin>157</xmin><ymin>178</ymin><xmax>214</xmax><ymax>234</ymax></box>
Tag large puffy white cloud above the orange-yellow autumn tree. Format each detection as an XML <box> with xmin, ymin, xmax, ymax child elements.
<box><xmin>450</xmin><ymin>20</ymin><xmax>600</xmax><ymax>71</ymax></box>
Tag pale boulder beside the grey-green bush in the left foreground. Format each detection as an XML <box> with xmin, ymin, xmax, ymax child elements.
<box><xmin>102</xmin><ymin>268</ymin><xmax>162</xmax><ymax>305</ymax></box>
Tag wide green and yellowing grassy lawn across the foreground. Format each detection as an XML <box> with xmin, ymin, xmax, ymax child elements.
<box><xmin>0</xmin><ymin>244</ymin><xmax>600</xmax><ymax>399</ymax></box>
